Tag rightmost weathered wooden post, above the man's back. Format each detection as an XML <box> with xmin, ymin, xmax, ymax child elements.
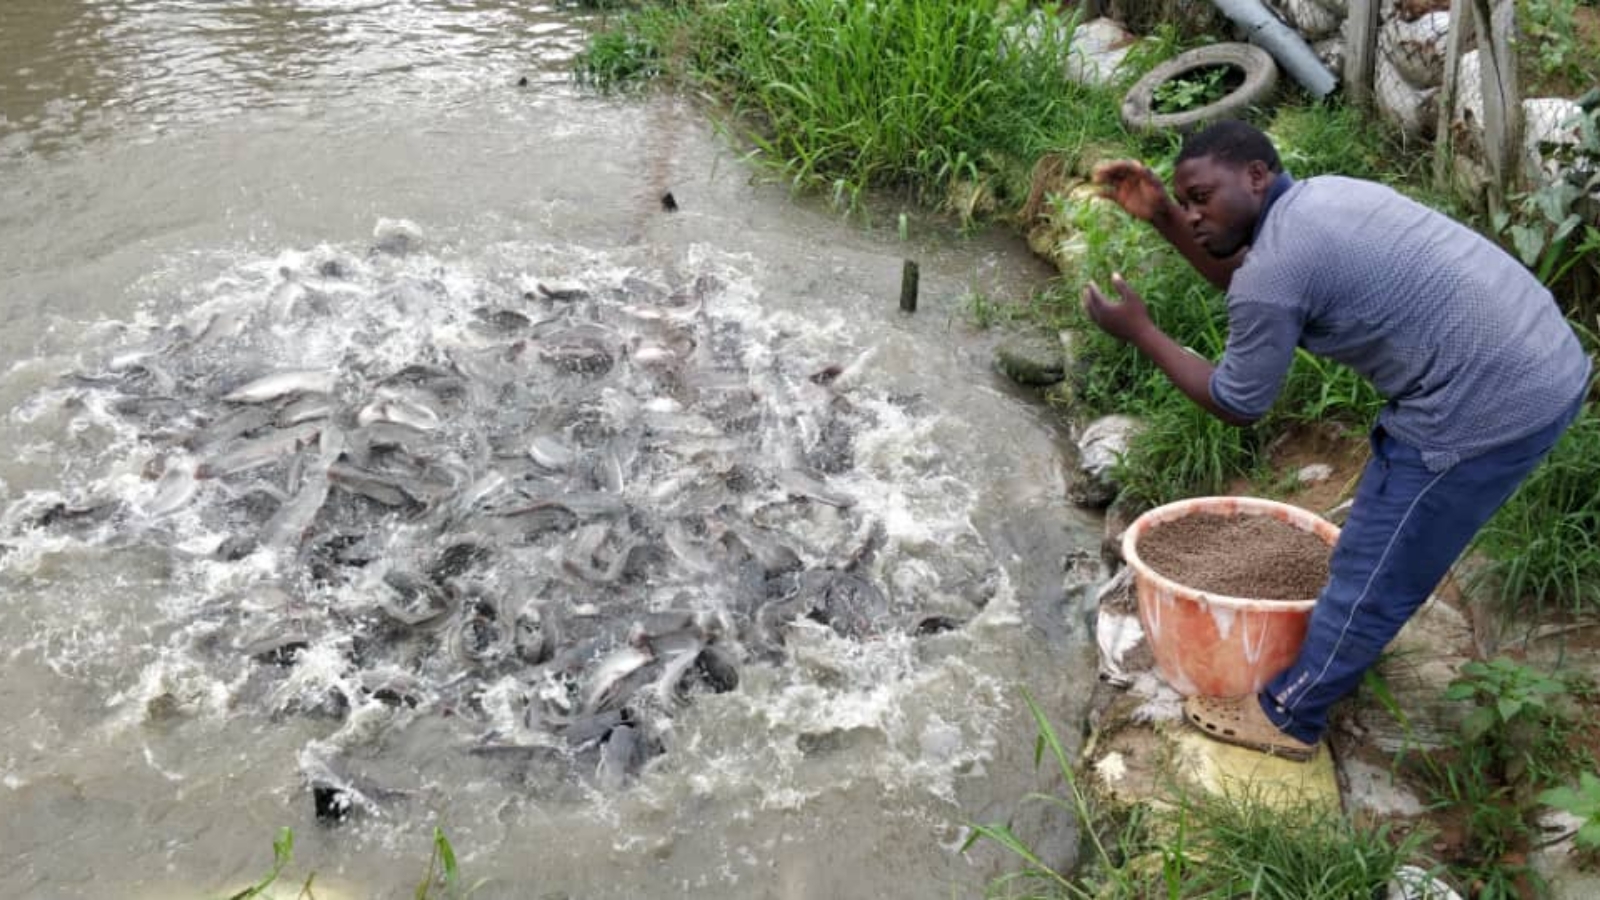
<box><xmin>1472</xmin><ymin>0</ymin><xmax>1522</xmax><ymax>211</ymax></box>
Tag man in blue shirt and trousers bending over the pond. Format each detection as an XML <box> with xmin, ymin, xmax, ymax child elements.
<box><xmin>1083</xmin><ymin>115</ymin><xmax>1590</xmax><ymax>759</ymax></box>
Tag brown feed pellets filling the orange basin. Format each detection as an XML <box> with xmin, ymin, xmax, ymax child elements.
<box><xmin>1138</xmin><ymin>512</ymin><xmax>1331</xmax><ymax>601</ymax></box>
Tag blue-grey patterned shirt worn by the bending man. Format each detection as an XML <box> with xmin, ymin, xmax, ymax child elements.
<box><xmin>1211</xmin><ymin>175</ymin><xmax>1590</xmax><ymax>471</ymax></box>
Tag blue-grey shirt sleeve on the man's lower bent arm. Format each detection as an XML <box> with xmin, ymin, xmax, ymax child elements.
<box><xmin>1211</xmin><ymin>301</ymin><xmax>1304</xmax><ymax>421</ymax></box>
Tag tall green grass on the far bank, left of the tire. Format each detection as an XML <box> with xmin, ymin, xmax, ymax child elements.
<box><xmin>579</xmin><ymin>0</ymin><xmax>1145</xmax><ymax>210</ymax></box>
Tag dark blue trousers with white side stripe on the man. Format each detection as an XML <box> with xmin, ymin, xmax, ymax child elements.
<box><xmin>1259</xmin><ymin>397</ymin><xmax>1582</xmax><ymax>743</ymax></box>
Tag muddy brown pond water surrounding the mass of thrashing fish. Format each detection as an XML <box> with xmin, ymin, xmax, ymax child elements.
<box><xmin>0</xmin><ymin>0</ymin><xmax>1099</xmax><ymax>900</ymax></box>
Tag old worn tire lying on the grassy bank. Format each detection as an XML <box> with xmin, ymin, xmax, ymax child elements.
<box><xmin>1122</xmin><ymin>43</ymin><xmax>1278</xmax><ymax>133</ymax></box>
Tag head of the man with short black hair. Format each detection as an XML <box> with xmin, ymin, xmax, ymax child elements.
<box><xmin>1173</xmin><ymin>120</ymin><xmax>1283</xmax><ymax>256</ymax></box>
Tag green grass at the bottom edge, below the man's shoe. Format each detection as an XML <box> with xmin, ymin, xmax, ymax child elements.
<box><xmin>963</xmin><ymin>695</ymin><xmax>1427</xmax><ymax>900</ymax></box>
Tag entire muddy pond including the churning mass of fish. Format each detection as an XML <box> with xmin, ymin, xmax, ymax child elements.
<box><xmin>0</xmin><ymin>0</ymin><xmax>1098</xmax><ymax>898</ymax></box>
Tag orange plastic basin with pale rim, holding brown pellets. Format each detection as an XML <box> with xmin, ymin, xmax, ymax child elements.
<box><xmin>1122</xmin><ymin>496</ymin><xmax>1339</xmax><ymax>697</ymax></box>
